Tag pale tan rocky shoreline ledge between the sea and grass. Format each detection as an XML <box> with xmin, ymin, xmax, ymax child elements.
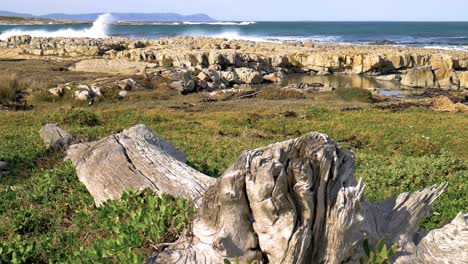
<box><xmin>0</xmin><ymin>36</ymin><xmax>468</xmax><ymax>93</ymax></box>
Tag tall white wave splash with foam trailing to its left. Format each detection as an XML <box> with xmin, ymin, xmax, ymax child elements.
<box><xmin>0</xmin><ymin>14</ymin><xmax>112</xmax><ymax>40</ymax></box>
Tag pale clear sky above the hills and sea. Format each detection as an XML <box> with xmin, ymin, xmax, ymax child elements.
<box><xmin>0</xmin><ymin>0</ymin><xmax>468</xmax><ymax>21</ymax></box>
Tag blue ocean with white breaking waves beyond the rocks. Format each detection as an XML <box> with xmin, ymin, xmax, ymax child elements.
<box><xmin>0</xmin><ymin>15</ymin><xmax>468</xmax><ymax>51</ymax></box>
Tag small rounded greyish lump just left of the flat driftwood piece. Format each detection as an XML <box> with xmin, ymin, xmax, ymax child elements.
<box><xmin>39</xmin><ymin>123</ymin><xmax>73</xmax><ymax>150</ymax></box>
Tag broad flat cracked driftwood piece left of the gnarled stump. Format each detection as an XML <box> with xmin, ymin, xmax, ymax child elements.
<box><xmin>65</xmin><ymin>125</ymin><xmax>215</xmax><ymax>206</ymax></box>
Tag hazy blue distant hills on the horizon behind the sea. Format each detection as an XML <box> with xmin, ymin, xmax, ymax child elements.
<box><xmin>0</xmin><ymin>11</ymin><xmax>215</xmax><ymax>22</ymax></box>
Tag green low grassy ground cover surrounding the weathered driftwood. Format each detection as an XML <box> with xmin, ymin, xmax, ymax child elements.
<box><xmin>0</xmin><ymin>87</ymin><xmax>468</xmax><ymax>263</ymax></box>
